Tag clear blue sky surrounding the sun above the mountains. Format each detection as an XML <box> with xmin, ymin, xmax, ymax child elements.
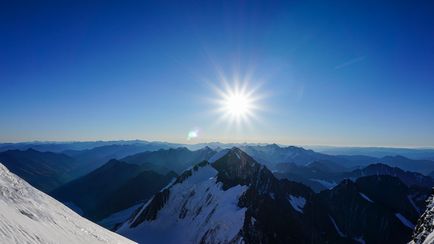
<box><xmin>0</xmin><ymin>1</ymin><xmax>434</xmax><ymax>146</ymax></box>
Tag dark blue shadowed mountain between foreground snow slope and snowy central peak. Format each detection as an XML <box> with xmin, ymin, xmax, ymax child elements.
<box><xmin>51</xmin><ymin>159</ymin><xmax>177</xmax><ymax>225</ymax></box>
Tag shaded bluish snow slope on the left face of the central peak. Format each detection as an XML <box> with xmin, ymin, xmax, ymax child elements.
<box><xmin>117</xmin><ymin>165</ymin><xmax>247</xmax><ymax>243</ymax></box>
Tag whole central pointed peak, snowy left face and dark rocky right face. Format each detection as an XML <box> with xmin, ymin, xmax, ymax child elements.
<box><xmin>117</xmin><ymin>148</ymin><xmax>356</xmax><ymax>243</ymax></box>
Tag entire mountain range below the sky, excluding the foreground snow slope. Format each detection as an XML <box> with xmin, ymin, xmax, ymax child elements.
<box><xmin>0</xmin><ymin>143</ymin><xmax>434</xmax><ymax>243</ymax></box>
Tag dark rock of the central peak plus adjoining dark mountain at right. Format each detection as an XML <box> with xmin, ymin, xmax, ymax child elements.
<box><xmin>222</xmin><ymin>149</ymin><xmax>423</xmax><ymax>243</ymax></box>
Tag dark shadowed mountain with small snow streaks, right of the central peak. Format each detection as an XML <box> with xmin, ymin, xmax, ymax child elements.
<box><xmin>319</xmin><ymin>176</ymin><xmax>417</xmax><ymax>243</ymax></box>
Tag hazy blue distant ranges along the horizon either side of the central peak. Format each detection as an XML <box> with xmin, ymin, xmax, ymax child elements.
<box><xmin>0</xmin><ymin>141</ymin><xmax>434</xmax><ymax>196</ymax></box>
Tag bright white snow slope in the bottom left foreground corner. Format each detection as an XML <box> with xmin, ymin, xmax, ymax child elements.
<box><xmin>0</xmin><ymin>163</ymin><xmax>133</xmax><ymax>243</ymax></box>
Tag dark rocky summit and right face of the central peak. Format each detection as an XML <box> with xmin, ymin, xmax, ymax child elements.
<box><xmin>212</xmin><ymin>148</ymin><xmax>344</xmax><ymax>243</ymax></box>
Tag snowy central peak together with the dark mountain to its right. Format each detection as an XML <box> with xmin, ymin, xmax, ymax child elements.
<box><xmin>117</xmin><ymin>148</ymin><xmax>428</xmax><ymax>243</ymax></box>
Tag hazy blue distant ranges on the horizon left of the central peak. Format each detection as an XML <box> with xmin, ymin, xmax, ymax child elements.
<box><xmin>0</xmin><ymin>144</ymin><xmax>202</xmax><ymax>193</ymax></box>
